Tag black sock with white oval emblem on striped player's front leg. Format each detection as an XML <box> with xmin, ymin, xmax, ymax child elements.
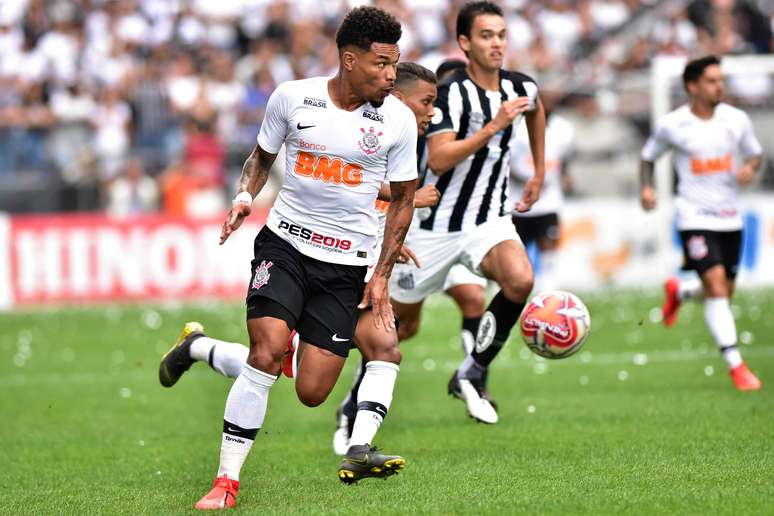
<box><xmin>471</xmin><ymin>290</ymin><xmax>526</xmax><ymax>367</ymax></box>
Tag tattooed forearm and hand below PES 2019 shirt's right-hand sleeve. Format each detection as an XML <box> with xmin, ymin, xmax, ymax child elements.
<box><xmin>360</xmin><ymin>180</ymin><xmax>416</xmax><ymax>331</ymax></box>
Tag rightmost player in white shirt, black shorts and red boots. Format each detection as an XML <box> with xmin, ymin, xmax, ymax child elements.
<box><xmin>640</xmin><ymin>56</ymin><xmax>761</xmax><ymax>391</ymax></box>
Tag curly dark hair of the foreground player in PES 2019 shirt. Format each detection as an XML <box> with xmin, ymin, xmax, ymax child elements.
<box><xmin>336</xmin><ymin>6</ymin><xmax>402</xmax><ymax>50</ymax></box>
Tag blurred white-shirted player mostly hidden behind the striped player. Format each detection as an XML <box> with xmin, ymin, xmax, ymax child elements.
<box><xmin>510</xmin><ymin>92</ymin><xmax>575</xmax><ymax>291</ymax></box>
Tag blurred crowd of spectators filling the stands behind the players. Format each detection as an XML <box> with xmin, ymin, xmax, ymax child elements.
<box><xmin>0</xmin><ymin>0</ymin><xmax>774</xmax><ymax>215</ymax></box>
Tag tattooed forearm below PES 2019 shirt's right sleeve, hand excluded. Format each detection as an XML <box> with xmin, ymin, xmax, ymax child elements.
<box><xmin>374</xmin><ymin>180</ymin><xmax>417</xmax><ymax>278</ymax></box>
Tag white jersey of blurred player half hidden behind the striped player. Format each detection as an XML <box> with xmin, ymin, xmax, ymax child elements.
<box><xmin>511</xmin><ymin>114</ymin><xmax>575</xmax><ymax>217</ymax></box>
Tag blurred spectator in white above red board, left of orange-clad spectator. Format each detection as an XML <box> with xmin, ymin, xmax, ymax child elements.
<box><xmin>106</xmin><ymin>155</ymin><xmax>159</xmax><ymax>217</ymax></box>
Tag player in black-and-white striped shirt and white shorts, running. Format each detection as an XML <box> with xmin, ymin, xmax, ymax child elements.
<box><xmin>390</xmin><ymin>2</ymin><xmax>545</xmax><ymax>423</ymax></box>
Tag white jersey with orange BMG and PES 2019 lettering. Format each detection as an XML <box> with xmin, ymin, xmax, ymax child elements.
<box><xmin>258</xmin><ymin>77</ymin><xmax>417</xmax><ymax>265</ymax></box>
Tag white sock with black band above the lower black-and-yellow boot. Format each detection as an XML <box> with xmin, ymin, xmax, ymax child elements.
<box><xmin>349</xmin><ymin>360</ymin><xmax>400</xmax><ymax>446</ymax></box>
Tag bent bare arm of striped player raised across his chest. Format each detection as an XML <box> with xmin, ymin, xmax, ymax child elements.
<box><xmin>427</xmin><ymin>97</ymin><xmax>545</xmax><ymax>176</ymax></box>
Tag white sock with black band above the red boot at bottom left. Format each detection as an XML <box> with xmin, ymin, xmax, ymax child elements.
<box><xmin>218</xmin><ymin>364</ymin><xmax>277</xmax><ymax>480</ymax></box>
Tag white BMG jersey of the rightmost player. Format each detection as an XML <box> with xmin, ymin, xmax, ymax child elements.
<box><xmin>642</xmin><ymin>104</ymin><xmax>761</xmax><ymax>231</ymax></box>
